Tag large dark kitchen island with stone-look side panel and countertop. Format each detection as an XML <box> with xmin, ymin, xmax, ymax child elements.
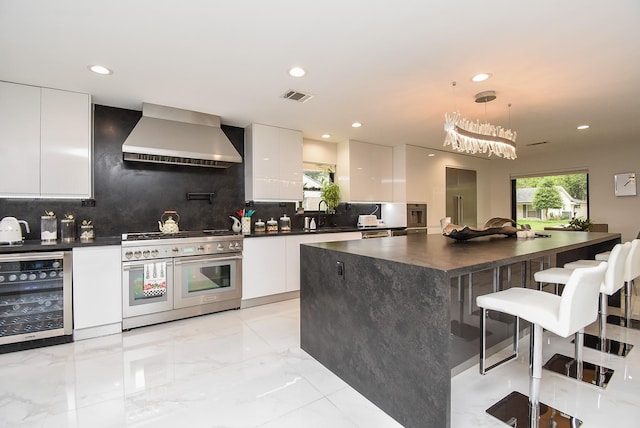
<box><xmin>300</xmin><ymin>232</ymin><xmax>620</xmax><ymax>428</ymax></box>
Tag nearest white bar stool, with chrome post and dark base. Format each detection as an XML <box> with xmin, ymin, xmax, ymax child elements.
<box><xmin>476</xmin><ymin>262</ymin><xmax>607</xmax><ymax>428</ymax></box>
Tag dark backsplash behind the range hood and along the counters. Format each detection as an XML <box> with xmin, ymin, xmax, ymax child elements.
<box><xmin>0</xmin><ymin>105</ymin><xmax>380</xmax><ymax>240</ymax></box>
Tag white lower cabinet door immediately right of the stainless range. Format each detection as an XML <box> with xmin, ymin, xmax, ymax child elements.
<box><xmin>242</xmin><ymin>236</ymin><xmax>286</xmax><ymax>300</ymax></box>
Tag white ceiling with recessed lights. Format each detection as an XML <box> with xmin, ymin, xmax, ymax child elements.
<box><xmin>0</xmin><ymin>0</ymin><xmax>640</xmax><ymax>158</ymax></box>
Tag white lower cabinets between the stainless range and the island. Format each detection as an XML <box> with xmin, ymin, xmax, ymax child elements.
<box><xmin>242</xmin><ymin>232</ymin><xmax>362</xmax><ymax>307</ymax></box>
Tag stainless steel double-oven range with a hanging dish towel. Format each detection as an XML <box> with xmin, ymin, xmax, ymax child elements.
<box><xmin>122</xmin><ymin>230</ymin><xmax>242</xmax><ymax>329</ymax></box>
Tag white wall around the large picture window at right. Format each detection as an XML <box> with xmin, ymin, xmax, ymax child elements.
<box><xmin>478</xmin><ymin>142</ymin><xmax>640</xmax><ymax>241</ymax></box>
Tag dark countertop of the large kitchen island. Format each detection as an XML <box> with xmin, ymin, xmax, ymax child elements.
<box><xmin>308</xmin><ymin>231</ymin><xmax>621</xmax><ymax>275</ymax></box>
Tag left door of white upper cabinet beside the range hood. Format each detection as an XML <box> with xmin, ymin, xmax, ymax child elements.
<box><xmin>251</xmin><ymin>124</ymin><xmax>280</xmax><ymax>201</ymax></box>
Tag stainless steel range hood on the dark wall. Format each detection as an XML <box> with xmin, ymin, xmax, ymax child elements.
<box><xmin>122</xmin><ymin>103</ymin><xmax>242</xmax><ymax>168</ymax></box>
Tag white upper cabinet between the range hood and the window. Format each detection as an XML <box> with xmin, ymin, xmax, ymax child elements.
<box><xmin>244</xmin><ymin>124</ymin><xmax>302</xmax><ymax>201</ymax></box>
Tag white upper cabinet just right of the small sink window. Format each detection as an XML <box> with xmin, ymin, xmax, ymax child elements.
<box><xmin>336</xmin><ymin>140</ymin><xmax>393</xmax><ymax>202</ymax></box>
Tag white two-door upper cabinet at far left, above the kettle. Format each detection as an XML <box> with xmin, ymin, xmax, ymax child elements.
<box><xmin>0</xmin><ymin>82</ymin><xmax>92</xmax><ymax>198</ymax></box>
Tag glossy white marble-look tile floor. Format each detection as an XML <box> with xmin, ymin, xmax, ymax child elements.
<box><xmin>0</xmin><ymin>299</ymin><xmax>640</xmax><ymax>428</ymax></box>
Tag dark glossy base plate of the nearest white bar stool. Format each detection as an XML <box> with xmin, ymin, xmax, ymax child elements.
<box><xmin>487</xmin><ymin>391</ymin><xmax>582</xmax><ymax>428</ymax></box>
